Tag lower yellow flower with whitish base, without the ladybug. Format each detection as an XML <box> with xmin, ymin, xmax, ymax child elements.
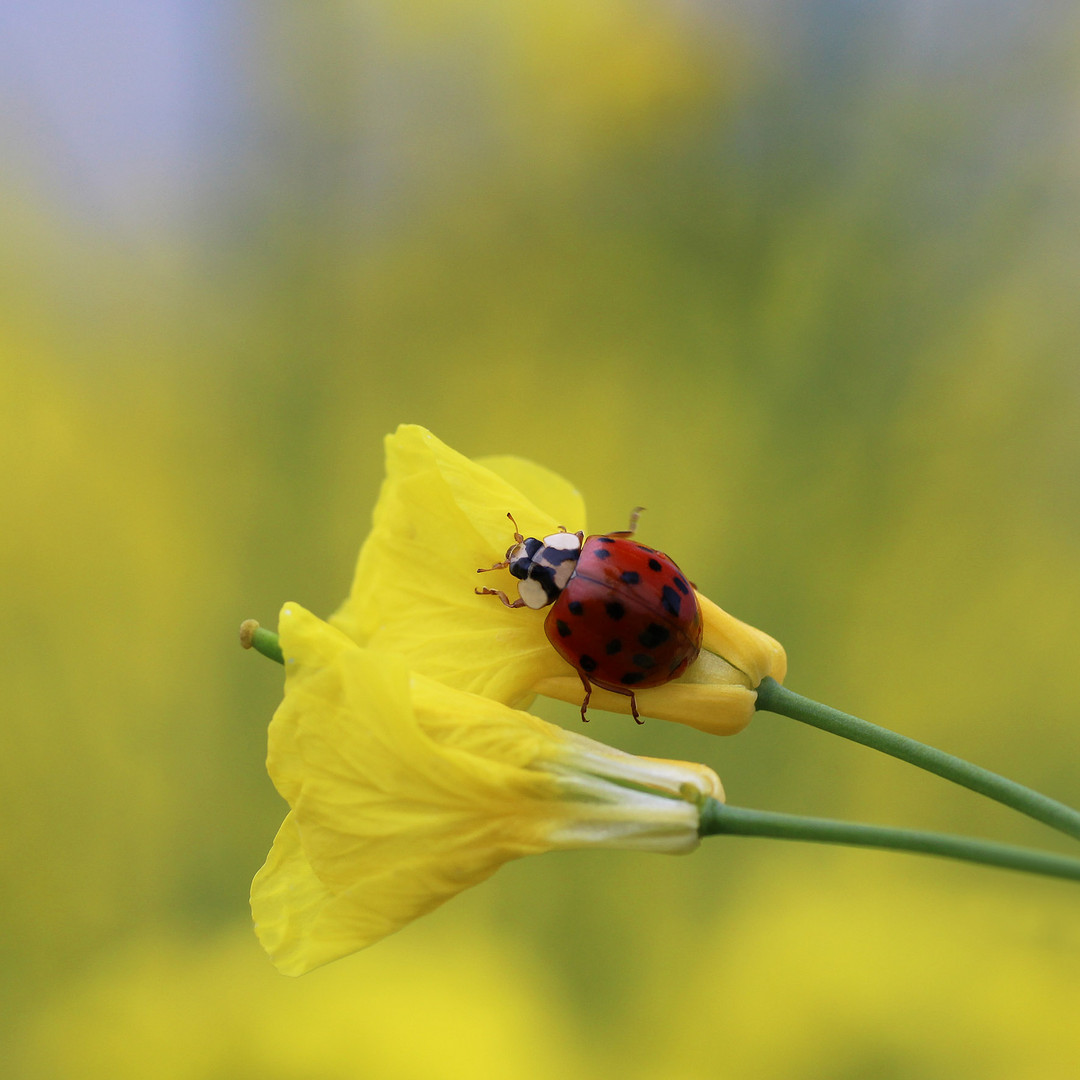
<box><xmin>252</xmin><ymin>604</ymin><xmax>724</xmax><ymax>975</ymax></box>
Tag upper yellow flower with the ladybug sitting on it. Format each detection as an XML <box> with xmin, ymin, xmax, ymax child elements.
<box><xmin>330</xmin><ymin>424</ymin><xmax>786</xmax><ymax>734</ymax></box>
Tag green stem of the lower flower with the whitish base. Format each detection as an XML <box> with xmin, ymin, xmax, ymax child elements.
<box><xmin>699</xmin><ymin>799</ymin><xmax>1080</xmax><ymax>881</ymax></box>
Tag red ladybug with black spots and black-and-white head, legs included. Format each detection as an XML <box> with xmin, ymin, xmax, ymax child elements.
<box><xmin>476</xmin><ymin>508</ymin><xmax>702</xmax><ymax>724</ymax></box>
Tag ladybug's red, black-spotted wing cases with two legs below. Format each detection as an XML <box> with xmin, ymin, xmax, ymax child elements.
<box><xmin>544</xmin><ymin>534</ymin><xmax>702</xmax><ymax>724</ymax></box>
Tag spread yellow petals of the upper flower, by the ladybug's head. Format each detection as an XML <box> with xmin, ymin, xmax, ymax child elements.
<box><xmin>330</xmin><ymin>426</ymin><xmax>577</xmax><ymax>705</ymax></box>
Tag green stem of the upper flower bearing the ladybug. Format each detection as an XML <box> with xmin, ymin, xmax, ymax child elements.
<box><xmin>757</xmin><ymin>678</ymin><xmax>1080</xmax><ymax>839</ymax></box>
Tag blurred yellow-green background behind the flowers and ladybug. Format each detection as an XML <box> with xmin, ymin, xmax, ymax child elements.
<box><xmin>0</xmin><ymin>0</ymin><xmax>1080</xmax><ymax>1080</ymax></box>
